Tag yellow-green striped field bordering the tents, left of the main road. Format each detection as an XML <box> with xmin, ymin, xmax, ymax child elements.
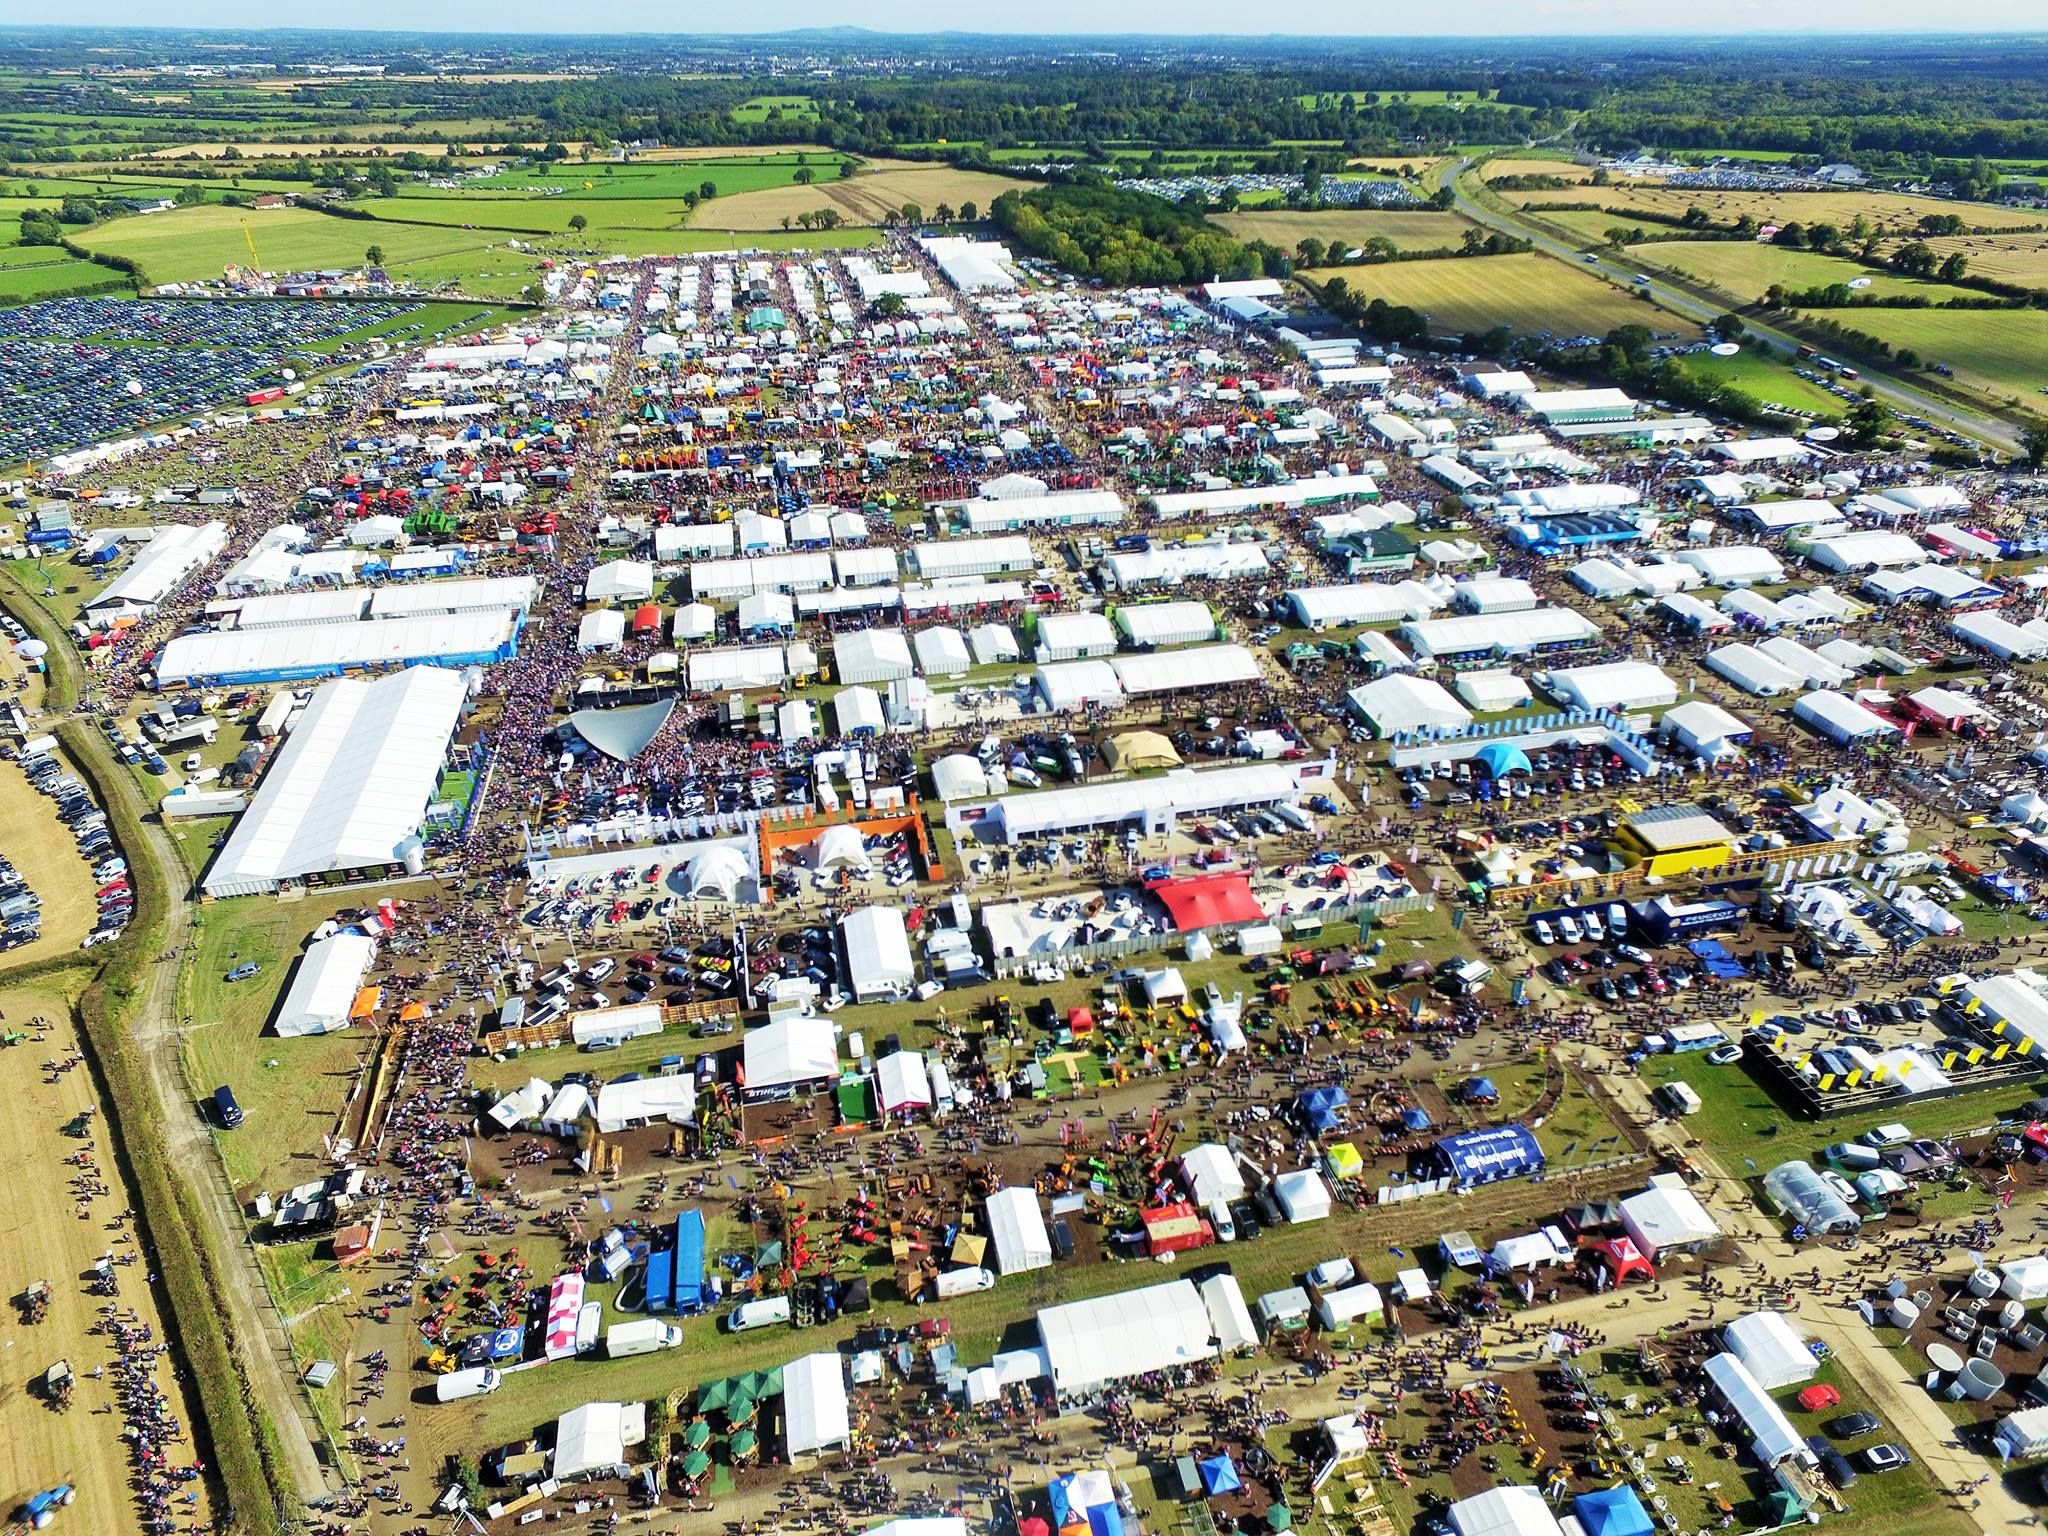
<box><xmin>1307</xmin><ymin>254</ymin><xmax>1698</xmax><ymax>338</ymax></box>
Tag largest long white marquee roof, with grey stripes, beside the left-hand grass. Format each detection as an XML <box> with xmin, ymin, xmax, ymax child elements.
<box><xmin>205</xmin><ymin>668</ymin><xmax>467</xmax><ymax>895</ymax></box>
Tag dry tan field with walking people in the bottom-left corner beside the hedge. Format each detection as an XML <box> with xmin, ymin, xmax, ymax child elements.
<box><xmin>0</xmin><ymin>971</ymin><xmax>218</xmax><ymax>1536</ymax></box>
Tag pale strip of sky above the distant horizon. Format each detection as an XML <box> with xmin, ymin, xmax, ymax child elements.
<box><xmin>24</xmin><ymin>0</ymin><xmax>2048</xmax><ymax>37</ymax></box>
